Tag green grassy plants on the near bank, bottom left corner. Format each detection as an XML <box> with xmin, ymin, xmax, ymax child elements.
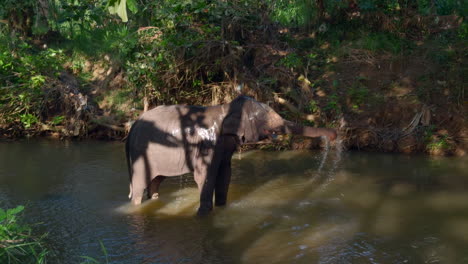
<box><xmin>0</xmin><ymin>205</ymin><xmax>50</xmax><ymax>264</ymax></box>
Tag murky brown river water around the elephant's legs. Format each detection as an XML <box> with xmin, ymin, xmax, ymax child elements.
<box><xmin>0</xmin><ymin>140</ymin><xmax>468</xmax><ymax>264</ymax></box>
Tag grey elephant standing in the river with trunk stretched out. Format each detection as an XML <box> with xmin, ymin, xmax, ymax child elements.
<box><xmin>125</xmin><ymin>96</ymin><xmax>337</xmax><ymax>215</ymax></box>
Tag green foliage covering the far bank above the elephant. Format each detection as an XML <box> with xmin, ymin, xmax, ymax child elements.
<box><xmin>0</xmin><ymin>0</ymin><xmax>468</xmax><ymax>142</ymax></box>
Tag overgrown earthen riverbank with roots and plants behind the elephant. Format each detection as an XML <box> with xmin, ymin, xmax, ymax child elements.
<box><xmin>0</xmin><ymin>1</ymin><xmax>468</xmax><ymax>156</ymax></box>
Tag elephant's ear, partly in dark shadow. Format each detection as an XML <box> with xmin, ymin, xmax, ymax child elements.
<box><xmin>222</xmin><ymin>96</ymin><xmax>259</xmax><ymax>145</ymax></box>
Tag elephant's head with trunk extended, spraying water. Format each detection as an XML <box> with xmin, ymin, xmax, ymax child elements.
<box><xmin>222</xmin><ymin>96</ymin><xmax>336</xmax><ymax>144</ymax></box>
